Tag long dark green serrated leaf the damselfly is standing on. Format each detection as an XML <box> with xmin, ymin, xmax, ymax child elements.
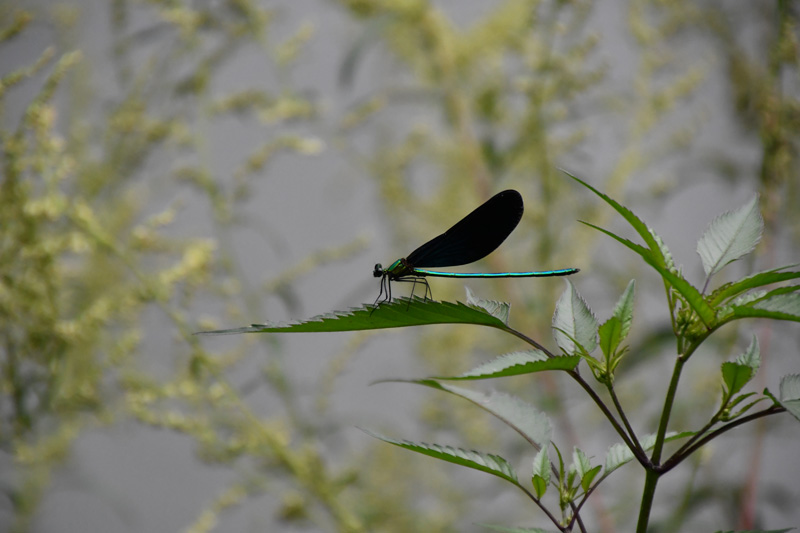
<box><xmin>197</xmin><ymin>298</ymin><xmax>506</xmax><ymax>335</ymax></box>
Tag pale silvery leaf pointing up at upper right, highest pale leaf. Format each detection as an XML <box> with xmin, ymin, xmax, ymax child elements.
<box><xmin>697</xmin><ymin>195</ymin><xmax>764</xmax><ymax>278</ymax></box>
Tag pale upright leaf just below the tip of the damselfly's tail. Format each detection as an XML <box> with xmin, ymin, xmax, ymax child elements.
<box><xmin>553</xmin><ymin>280</ymin><xmax>597</xmax><ymax>355</ymax></box>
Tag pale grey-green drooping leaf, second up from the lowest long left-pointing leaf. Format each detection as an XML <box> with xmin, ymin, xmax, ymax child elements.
<box><xmin>400</xmin><ymin>379</ymin><xmax>553</xmax><ymax>448</ymax></box>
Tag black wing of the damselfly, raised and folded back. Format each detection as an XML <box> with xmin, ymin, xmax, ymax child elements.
<box><xmin>406</xmin><ymin>189</ymin><xmax>524</xmax><ymax>268</ymax></box>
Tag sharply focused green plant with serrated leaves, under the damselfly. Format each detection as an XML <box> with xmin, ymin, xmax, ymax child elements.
<box><xmin>206</xmin><ymin>175</ymin><xmax>800</xmax><ymax>533</ymax></box>
